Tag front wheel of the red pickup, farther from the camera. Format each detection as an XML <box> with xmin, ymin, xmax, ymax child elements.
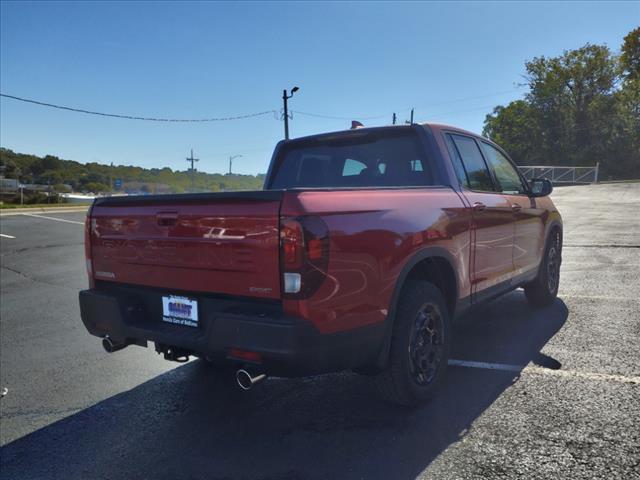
<box><xmin>524</xmin><ymin>229</ymin><xmax>562</xmax><ymax>307</ymax></box>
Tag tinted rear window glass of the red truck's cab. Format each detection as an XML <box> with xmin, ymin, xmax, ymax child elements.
<box><xmin>270</xmin><ymin>130</ymin><xmax>432</xmax><ymax>189</ymax></box>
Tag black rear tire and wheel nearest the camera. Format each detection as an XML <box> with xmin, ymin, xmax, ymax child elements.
<box><xmin>375</xmin><ymin>281</ymin><xmax>451</xmax><ymax>406</ymax></box>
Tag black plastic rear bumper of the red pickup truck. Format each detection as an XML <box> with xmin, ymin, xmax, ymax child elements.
<box><xmin>80</xmin><ymin>286</ymin><xmax>385</xmax><ymax>376</ymax></box>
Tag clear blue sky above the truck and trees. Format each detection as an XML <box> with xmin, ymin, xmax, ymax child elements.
<box><xmin>0</xmin><ymin>2</ymin><xmax>640</xmax><ymax>173</ymax></box>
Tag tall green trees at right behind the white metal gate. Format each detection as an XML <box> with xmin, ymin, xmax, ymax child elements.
<box><xmin>483</xmin><ymin>27</ymin><xmax>640</xmax><ymax>179</ymax></box>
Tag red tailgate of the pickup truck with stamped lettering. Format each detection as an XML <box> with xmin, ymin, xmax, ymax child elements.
<box><xmin>90</xmin><ymin>191</ymin><xmax>282</xmax><ymax>298</ymax></box>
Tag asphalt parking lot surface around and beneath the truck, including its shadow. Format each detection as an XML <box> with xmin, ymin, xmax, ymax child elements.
<box><xmin>0</xmin><ymin>183</ymin><xmax>640</xmax><ymax>479</ymax></box>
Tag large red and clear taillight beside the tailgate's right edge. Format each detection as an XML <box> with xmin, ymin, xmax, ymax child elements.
<box><xmin>280</xmin><ymin>217</ymin><xmax>329</xmax><ymax>298</ymax></box>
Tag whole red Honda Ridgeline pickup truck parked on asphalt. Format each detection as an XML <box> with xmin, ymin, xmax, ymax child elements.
<box><xmin>80</xmin><ymin>124</ymin><xmax>562</xmax><ymax>405</ymax></box>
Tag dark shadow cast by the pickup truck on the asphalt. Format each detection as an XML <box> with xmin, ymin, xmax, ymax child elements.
<box><xmin>0</xmin><ymin>292</ymin><xmax>568</xmax><ymax>480</ymax></box>
